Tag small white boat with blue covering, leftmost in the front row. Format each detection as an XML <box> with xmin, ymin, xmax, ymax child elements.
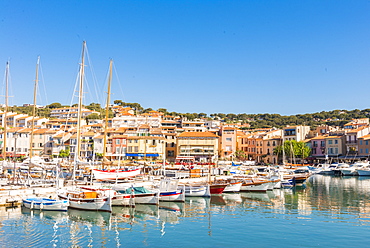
<box><xmin>22</xmin><ymin>197</ymin><xmax>69</xmax><ymax>211</ymax></box>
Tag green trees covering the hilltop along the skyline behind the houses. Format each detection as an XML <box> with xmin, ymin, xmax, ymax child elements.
<box><xmin>5</xmin><ymin>100</ymin><xmax>370</xmax><ymax>129</ymax></box>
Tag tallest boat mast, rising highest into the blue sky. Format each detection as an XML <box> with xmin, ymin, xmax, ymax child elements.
<box><xmin>73</xmin><ymin>41</ymin><xmax>86</xmax><ymax>180</ymax></box>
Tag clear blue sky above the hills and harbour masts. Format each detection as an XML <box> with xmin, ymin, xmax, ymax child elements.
<box><xmin>0</xmin><ymin>0</ymin><xmax>370</xmax><ymax>115</ymax></box>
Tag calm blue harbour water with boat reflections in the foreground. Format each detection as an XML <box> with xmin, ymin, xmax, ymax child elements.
<box><xmin>0</xmin><ymin>176</ymin><xmax>370</xmax><ymax>247</ymax></box>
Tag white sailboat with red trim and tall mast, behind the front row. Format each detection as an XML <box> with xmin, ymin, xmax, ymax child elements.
<box><xmin>92</xmin><ymin>60</ymin><xmax>141</xmax><ymax>181</ymax></box>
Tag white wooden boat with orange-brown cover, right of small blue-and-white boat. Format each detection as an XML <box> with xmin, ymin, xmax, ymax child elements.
<box><xmin>58</xmin><ymin>189</ymin><xmax>112</xmax><ymax>212</ymax></box>
